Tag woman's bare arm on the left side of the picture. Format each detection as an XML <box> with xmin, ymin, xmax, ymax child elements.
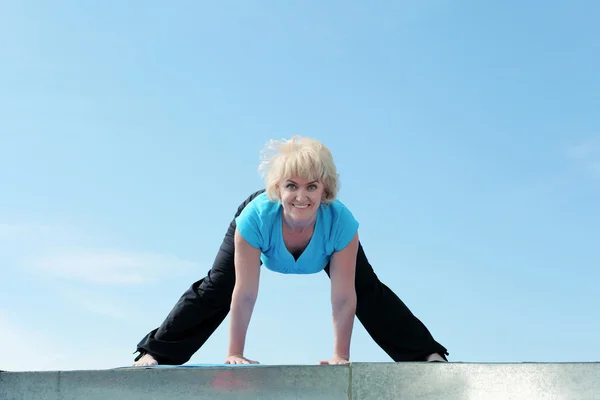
<box><xmin>225</xmin><ymin>229</ymin><xmax>260</xmax><ymax>364</ymax></box>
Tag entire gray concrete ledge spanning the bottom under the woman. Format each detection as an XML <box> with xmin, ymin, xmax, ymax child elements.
<box><xmin>0</xmin><ymin>363</ymin><xmax>600</xmax><ymax>400</ymax></box>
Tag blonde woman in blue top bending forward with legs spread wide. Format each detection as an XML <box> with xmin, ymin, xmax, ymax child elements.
<box><xmin>134</xmin><ymin>137</ymin><xmax>448</xmax><ymax>366</ymax></box>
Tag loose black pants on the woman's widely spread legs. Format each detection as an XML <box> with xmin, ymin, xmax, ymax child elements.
<box><xmin>136</xmin><ymin>190</ymin><xmax>448</xmax><ymax>365</ymax></box>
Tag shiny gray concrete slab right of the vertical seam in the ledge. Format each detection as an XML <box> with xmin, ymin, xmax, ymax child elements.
<box><xmin>352</xmin><ymin>363</ymin><xmax>600</xmax><ymax>400</ymax></box>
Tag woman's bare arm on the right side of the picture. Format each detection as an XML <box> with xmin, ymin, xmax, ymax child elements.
<box><xmin>321</xmin><ymin>233</ymin><xmax>358</xmax><ymax>364</ymax></box>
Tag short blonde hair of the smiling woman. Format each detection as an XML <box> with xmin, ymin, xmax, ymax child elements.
<box><xmin>258</xmin><ymin>136</ymin><xmax>339</xmax><ymax>204</ymax></box>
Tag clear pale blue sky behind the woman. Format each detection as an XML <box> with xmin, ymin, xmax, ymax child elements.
<box><xmin>0</xmin><ymin>0</ymin><xmax>600</xmax><ymax>369</ymax></box>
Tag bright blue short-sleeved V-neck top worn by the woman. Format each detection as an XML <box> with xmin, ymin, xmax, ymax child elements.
<box><xmin>235</xmin><ymin>193</ymin><xmax>359</xmax><ymax>274</ymax></box>
